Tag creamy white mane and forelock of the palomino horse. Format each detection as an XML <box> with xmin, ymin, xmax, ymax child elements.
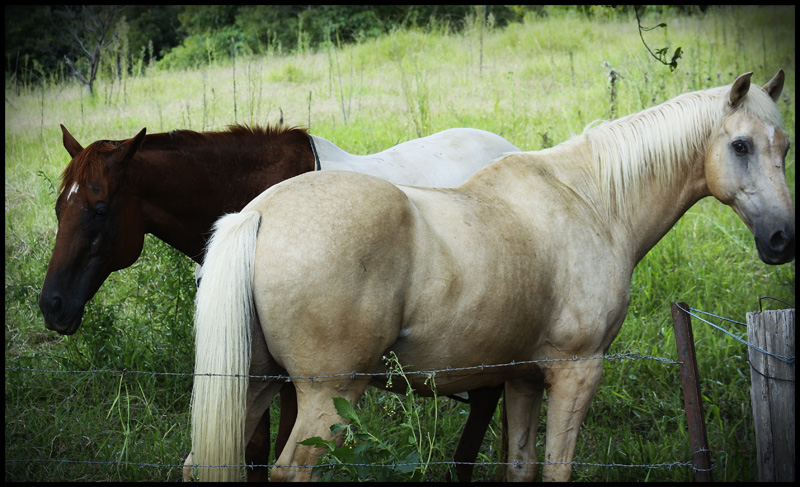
<box><xmin>583</xmin><ymin>81</ymin><xmax>781</xmax><ymax>214</ymax></box>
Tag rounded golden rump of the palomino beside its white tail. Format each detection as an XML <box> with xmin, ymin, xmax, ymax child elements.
<box><xmin>253</xmin><ymin>171</ymin><xmax>413</xmax><ymax>378</ymax></box>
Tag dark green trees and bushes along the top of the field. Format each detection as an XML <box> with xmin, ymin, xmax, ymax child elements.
<box><xmin>5</xmin><ymin>5</ymin><xmax>520</xmax><ymax>83</ymax></box>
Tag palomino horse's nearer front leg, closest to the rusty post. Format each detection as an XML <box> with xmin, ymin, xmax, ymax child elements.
<box><xmin>542</xmin><ymin>358</ymin><xmax>603</xmax><ymax>482</ymax></box>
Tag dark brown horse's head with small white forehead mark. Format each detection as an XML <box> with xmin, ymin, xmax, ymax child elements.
<box><xmin>39</xmin><ymin>125</ymin><xmax>146</xmax><ymax>335</ymax></box>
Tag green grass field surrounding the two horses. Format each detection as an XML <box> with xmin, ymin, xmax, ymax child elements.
<box><xmin>5</xmin><ymin>7</ymin><xmax>796</xmax><ymax>481</ymax></box>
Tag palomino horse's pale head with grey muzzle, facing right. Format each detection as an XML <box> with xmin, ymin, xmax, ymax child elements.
<box><xmin>705</xmin><ymin>70</ymin><xmax>794</xmax><ymax>264</ymax></box>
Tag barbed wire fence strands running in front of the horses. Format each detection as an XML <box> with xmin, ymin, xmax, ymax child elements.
<box><xmin>6</xmin><ymin>306</ymin><xmax>795</xmax><ymax>480</ymax></box>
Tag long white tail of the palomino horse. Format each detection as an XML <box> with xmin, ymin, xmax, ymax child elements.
<box><xmin>192</xmin><ymin>211</ymin><xmax>261</xmax><ymax>481</ymax></box>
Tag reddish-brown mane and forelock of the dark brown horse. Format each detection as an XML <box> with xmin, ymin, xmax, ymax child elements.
<box><xmin>59</xmin><ymin>124</ymin><xmax>308</xmax><ymax>192</ymax></box>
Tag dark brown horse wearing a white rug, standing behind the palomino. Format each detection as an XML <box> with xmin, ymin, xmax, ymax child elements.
<box><xmin>39</xmin><ymin>125</ymin><xmax>519</xmax><ymax>479</ymax></box>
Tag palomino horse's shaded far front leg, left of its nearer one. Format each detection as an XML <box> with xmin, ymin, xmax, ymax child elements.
<box><xmin>505</xmin><ymin>379</ymin><xmax>544</xmax><ymax>482</ymax></box>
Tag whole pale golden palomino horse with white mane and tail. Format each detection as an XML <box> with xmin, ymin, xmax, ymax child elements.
<box><xmin>192</xmin><ymin>71</ymin><xmax>795</xmax><ymax>480</ymax></box>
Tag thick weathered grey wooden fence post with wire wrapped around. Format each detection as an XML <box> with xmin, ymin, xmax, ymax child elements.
<box><xmin>747</xmin><ymin>309</ymin><xmax>795</xmax><ymax>482</ymax></box>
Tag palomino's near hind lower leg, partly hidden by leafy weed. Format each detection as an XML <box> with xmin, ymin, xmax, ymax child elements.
<box><xmin>271</xmin><ymin>377</ymin><xmax>369</xmax><ymax>482</ymax></box>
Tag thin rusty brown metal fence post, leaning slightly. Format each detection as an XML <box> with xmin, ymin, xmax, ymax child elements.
<box><xmin>672</xmin><ymin>303</ymin><xmax>713</xmax><ymax>482</ymax></box>
